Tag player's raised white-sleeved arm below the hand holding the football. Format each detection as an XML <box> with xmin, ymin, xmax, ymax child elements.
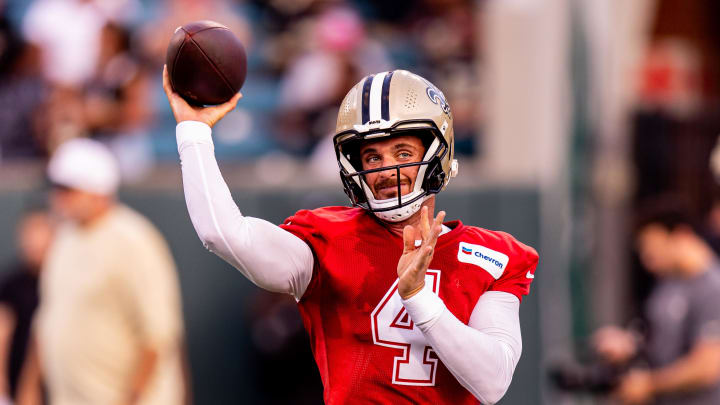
<box><xmin>177</xmin><ymin>121</ymin><xmax>313</xmax><ymax>298</ymax></box>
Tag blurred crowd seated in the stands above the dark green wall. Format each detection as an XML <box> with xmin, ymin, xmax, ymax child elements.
<box><xmin>0</xmin><ymin>0</ymin><xmax>477</xmax><ymax>174</ymax></box>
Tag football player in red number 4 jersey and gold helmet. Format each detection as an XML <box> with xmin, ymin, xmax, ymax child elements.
<box><xmin>163</xmin><ymin>70</ymin><xmax>538</xmax><ymax>404</ymax></box>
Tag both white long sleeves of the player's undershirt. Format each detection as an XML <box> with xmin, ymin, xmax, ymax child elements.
<box><xmin>176</xmin><ymin>121</ymin><xmax>522</xmax><ymax>404</ymax></box>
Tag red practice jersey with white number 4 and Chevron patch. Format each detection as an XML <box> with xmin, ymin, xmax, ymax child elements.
<box><xmin>281</xmin><ymin>207</ymin><xmax>538</xmax><ymax>405</ymax></box>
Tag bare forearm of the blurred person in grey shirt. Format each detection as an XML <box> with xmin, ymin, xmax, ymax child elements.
<box><xmin>650</xmin><ymin>341</ymin><xmax>720</xmax><ymax>394</ymax></box>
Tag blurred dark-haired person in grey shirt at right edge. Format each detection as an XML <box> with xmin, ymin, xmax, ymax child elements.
<box><xmin>594</xmin><ymin>199</ymin><xmax>720</xmax><ymax>405</ymax></box>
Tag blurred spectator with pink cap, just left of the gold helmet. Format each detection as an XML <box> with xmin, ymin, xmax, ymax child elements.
<box><xmin>273</xmin><ymin>6</ymin><xmax>390</xmax><ymax>155</ymax></box>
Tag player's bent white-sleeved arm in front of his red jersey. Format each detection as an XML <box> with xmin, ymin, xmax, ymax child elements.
<box><xmin>403</xmin><ymin>289</ymin><xmax>522</xmax><ymax>404</ymax></box>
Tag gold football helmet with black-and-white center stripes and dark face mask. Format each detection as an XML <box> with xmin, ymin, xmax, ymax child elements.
<box><xmin>333</xmin><ymin>70</ymin><xmax>458</xmax><ymax>222</ymax></box>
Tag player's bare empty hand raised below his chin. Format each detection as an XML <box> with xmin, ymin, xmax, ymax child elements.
<box><xmin>398</xmin><ymin>207</ymin><xmax>445</xmax><ymax>300</ymax></box>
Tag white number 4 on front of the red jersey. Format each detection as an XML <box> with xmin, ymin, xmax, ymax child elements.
<box><xmin>370</xmin><ymin>270</ymin><xmax>440</xmax><ymax>386</ymax></box>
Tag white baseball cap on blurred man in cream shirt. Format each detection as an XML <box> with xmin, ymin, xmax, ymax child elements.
<box><xmin>47</xmin><ymin>138</ymin><xmax>120</xmax><ymax>195</ymax></box>
